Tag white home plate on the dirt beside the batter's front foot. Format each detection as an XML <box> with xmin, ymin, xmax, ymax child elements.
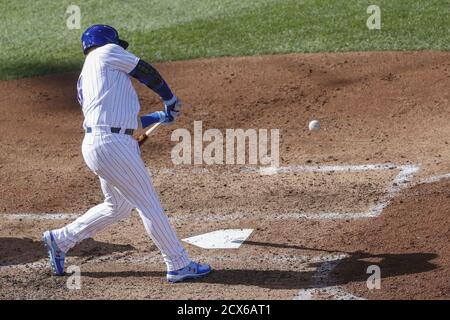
<box><xmin>183</xmin><ymin>229</ymin><xmax>253</xmax><ymax>249</ymax></box>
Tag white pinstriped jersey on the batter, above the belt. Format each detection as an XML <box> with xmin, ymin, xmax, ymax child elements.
<box><xmin>77</xmin><ymin>44</ymin><xmax>140</xmax><ymax>129</ymax></box>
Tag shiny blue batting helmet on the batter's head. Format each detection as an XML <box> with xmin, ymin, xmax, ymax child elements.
<box><xmin>81</xmin><ymin>24</ymin><xmax>128</xmax><ymax>54</ymax></box>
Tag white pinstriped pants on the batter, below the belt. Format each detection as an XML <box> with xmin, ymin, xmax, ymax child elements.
<box><xmin>53</xmin><ymin>128</ymin><xmax>190</xmax><ymax>271</ymax></box>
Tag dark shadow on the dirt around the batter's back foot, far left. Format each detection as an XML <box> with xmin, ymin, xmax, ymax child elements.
<box><xmin>0</xmin><ymin>237</ymin><xmax>135</xmax><ymax>266</ymax></box>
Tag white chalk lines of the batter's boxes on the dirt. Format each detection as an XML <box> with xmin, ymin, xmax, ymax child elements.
<box><xmin>0</xmin><ymin>163</ymin><xmax>444</xmax><ymax>300</ymax></box>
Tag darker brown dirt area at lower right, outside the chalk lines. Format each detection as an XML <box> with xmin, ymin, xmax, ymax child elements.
<box><xmin>333</xmin><ymin>181</ymin><xmax>450</xmax><ymax>299</ymax></box>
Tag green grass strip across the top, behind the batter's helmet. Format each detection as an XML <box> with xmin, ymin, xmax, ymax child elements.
<box><xmin>0</xmin><ymin>0</ymin><xmax>450</xmax><ymax>79</ymax></box>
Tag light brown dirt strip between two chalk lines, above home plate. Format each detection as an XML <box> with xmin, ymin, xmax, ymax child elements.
<box><xmin>150</xmin><ymin>170</ymin><xmax>393</xmax><ymax>215</ymax></box>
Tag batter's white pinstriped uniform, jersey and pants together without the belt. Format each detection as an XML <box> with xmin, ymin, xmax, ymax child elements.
<box><xmin>52</xmin><ymin>44</ymin><xmax>190</xmax><ymax>271</ymax></box>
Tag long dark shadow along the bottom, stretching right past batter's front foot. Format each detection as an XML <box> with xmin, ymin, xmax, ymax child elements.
<box><xmin>79</xmin><ymin>241</ymin><xmax>438</xmax><ymax>289</ymax></box>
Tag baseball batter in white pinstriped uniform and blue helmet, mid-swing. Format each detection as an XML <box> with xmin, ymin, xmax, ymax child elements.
<box><xmin>43</xmin><ymin>25</ymin><xmax>211</xmax><ymax>282</ymax></box>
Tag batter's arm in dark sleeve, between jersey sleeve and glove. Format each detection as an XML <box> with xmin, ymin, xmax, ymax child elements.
<box><xmin>130</xmin><ymin>59</ymin><xmax>176</xmax><ymax>105</ymax></box>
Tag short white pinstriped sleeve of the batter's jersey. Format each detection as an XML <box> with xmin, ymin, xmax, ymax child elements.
<box><xmin>99</xmin><ymin>44</ymin><xmax>139</xmax><ymax>73</ymax></box>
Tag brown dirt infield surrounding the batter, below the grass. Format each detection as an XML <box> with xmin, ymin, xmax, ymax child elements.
<box><xmin>0</xmin><ymin>52</ymin><xmax>450</xmax><ymax>299</ymax></box>
